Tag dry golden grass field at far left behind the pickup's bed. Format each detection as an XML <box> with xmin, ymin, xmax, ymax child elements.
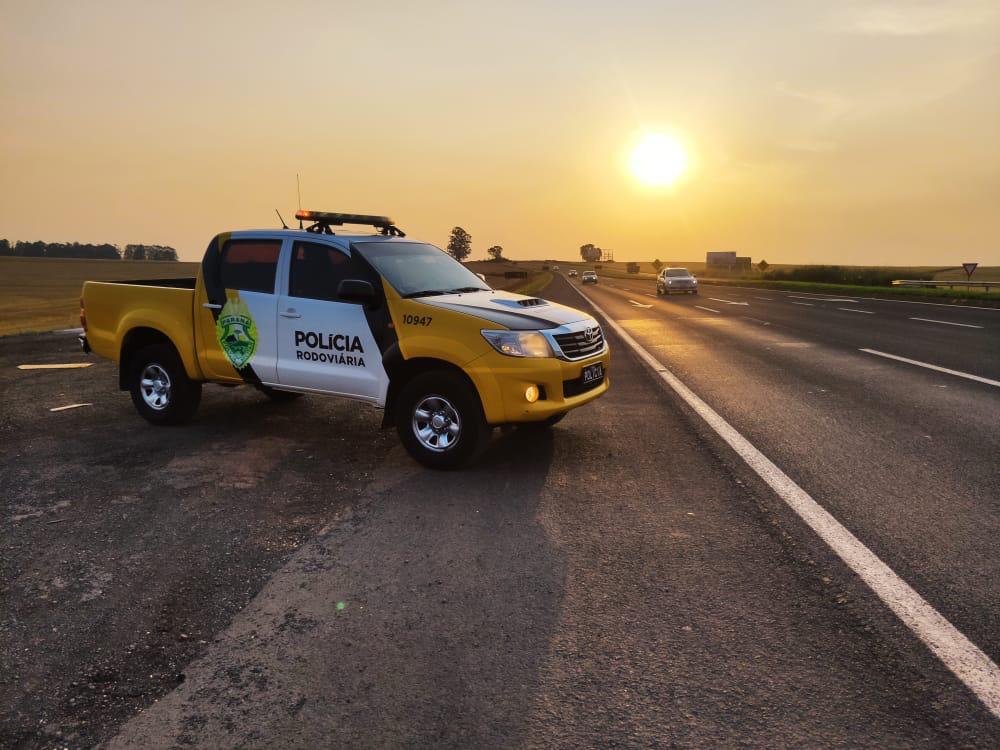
<box><xmin>0</xmin><ymin>258</ymin><xmax>198</xmax><ymax>336</ymax></box>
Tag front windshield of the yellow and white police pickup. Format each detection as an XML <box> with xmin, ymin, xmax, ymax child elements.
<box><xmin>353</xmin><ymin>242</ymin><xmax>490</xmax><ymax>297</ymax></box>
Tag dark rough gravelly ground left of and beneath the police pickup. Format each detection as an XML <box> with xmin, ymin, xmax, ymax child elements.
<box><xmin>0</xmin><ymin>335</ymin><xmax>395</xmax><ymax>748</ymax></box>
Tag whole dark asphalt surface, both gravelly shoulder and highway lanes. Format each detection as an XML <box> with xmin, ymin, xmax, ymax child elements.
<box><xmin>0</xmin><ymin>277</ymin><xmax>1000</xmax><ymax>748</ymax></box>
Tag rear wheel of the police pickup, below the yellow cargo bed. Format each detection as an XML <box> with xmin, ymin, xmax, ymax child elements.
<box><xmin>127</xmin><ymin>344</ymin><xmax>201</xmax><ymax>425</ymax></box>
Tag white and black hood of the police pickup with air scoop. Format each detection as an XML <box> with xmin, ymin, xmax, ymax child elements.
<box><xmin>416</xmin><ymin>291</ymin><xmax>593</xmax><ymax>331</ymax></box>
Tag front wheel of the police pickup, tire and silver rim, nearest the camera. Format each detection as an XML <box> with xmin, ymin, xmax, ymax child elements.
<box><xmin>394</xmin><ymin>370</ymin><xmax>492</xmax><ymax>469</ymax></box>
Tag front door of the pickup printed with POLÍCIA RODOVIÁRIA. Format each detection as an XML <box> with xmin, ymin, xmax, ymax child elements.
<box><xmin>277</xmin><ymin>240</ymin><xmax>388</xmax><ymax>403</ymax></box>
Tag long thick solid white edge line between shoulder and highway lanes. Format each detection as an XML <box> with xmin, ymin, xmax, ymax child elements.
<box><xmin>574</xmin><ymin>287</ymin><xmax>1000</xmax><ymax>718</ymax></box>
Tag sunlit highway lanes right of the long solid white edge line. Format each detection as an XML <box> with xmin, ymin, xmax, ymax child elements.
<box><xmin>585</xmin><ymin>279</ymin><xmax>1000</xmax><ymax>661</ymax></box>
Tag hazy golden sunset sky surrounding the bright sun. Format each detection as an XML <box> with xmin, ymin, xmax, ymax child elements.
<box><xmin>0</xmin><ymin>0</ymin><xmax>1000</xmax><ymax>265</ymax></box>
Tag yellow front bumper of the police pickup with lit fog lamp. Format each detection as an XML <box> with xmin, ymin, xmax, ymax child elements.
<box><xmin>465</xmin><ymin>345</ymin><xmax>611</xmax><ymax>424</ymax></box>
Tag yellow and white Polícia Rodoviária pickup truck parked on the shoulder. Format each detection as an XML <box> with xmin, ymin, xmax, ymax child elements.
<box><xmin>80</xmin><ymin>211</ymin><xmax>610</xmax><ymax>468</ymax></box>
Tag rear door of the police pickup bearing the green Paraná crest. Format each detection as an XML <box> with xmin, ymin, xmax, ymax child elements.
<box><xmin>195</xmin><ymin>235</ymin><xmax>282</xmax><ymax>383</ymax></box>
